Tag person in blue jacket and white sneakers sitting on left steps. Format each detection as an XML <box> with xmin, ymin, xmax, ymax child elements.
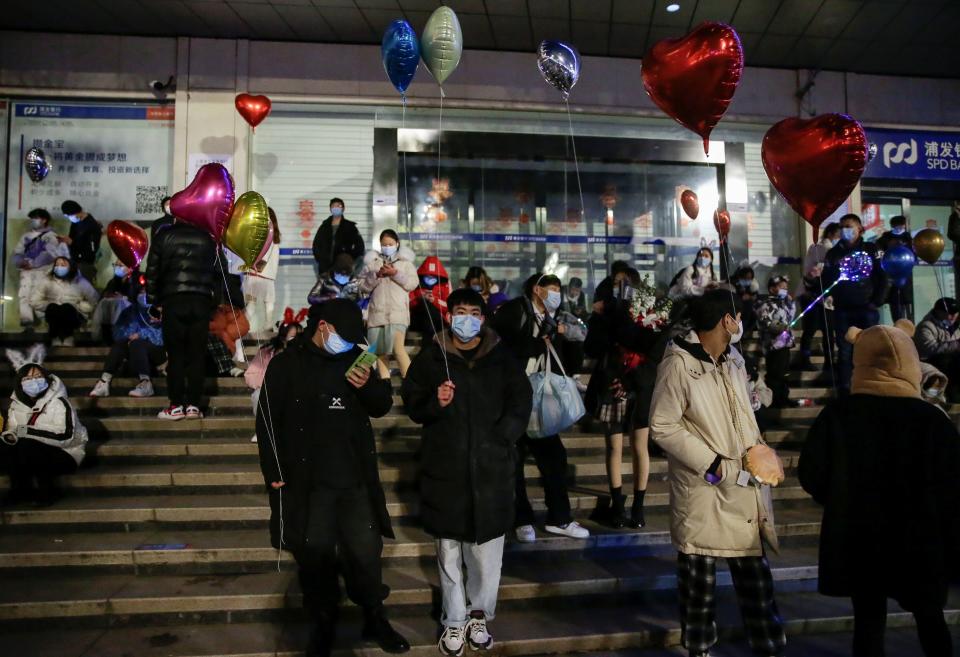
<box><xmin>89</xmin><ymin>292</ymin><xmax>167</xmax><ymax>397</ymax></box>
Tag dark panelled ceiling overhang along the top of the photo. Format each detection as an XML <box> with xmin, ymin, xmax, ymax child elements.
<box><xmin>0</xmin><ymin>0</ymin><xmax>960</xmax><ymax>77</ymax></box>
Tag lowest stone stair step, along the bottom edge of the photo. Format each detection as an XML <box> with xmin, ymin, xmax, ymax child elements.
<box><xmin>0</xmin><ymin>588</ymin><xmax>960</xmax><ymax>657</ymax></box>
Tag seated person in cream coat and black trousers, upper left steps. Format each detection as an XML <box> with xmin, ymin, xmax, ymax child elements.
<box><xmin>30</xmin><ymin>256</ymin><xmax>100</xmax><ymax>347</ymax></box>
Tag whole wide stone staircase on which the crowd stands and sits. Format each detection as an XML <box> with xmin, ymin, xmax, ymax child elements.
<box><xmin>0</xmin><ymin>335</ymin><xmax>960</xmax><ymax>657</ymax></box>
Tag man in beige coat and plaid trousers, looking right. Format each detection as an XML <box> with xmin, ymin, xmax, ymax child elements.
<box><xmin>650</xmin><ymin>290</ymin><xmax>786</xmax><ymax>657</ymax></box>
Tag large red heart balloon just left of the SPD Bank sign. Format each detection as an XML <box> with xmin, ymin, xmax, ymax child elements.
<box><xmin>760</xmin><ymin>114</ymin><xmax>867</xmax><ymax>231</ymax></box>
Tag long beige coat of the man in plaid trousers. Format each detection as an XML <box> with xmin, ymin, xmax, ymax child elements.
<box><xmin>650</xmin><ymin>332</ymin><xmax>777</xmax><ymax>557</ymax></box>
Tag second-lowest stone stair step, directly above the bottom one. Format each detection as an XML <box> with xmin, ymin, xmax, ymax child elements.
<box><xmin>0</xmin><ymin>546</ymin><xmax>817</xmax><ymax>623</ymax></box>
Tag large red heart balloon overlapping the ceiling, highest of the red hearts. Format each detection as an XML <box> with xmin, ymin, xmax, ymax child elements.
<box><xmin>640</xmin><ymin>22</ymin><xmax>743</xmax><ymax>153</ymax></box>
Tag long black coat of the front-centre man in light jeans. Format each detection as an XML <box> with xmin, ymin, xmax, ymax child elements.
<box><xmin>400</xmin><ymin>328</ymin><xmax>533</xmax><ymax>543</ymax></box>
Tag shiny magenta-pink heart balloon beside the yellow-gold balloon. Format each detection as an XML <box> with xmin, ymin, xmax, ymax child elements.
<box><xmin>170</xmin><ymin>162</ymin><xmax>234</xmax><ymax>242</ymax></box>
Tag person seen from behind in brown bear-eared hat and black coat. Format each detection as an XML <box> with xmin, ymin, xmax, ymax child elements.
<box><xmin>798</xmin><ymin>319</ymin><xmax>960</xmax><ymax>657</ymax></box>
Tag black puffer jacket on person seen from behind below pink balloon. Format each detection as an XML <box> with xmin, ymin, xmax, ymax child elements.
<box><xmin>147</xmin><ymin>221</ymin><xmax>220</xmax><ymax>305</ymax></box>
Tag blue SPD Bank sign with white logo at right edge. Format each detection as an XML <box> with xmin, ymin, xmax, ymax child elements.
<box><xmin>863</xmin><ymin>128</ymin><xmax>960</xmax><ymax>181</ymax></box>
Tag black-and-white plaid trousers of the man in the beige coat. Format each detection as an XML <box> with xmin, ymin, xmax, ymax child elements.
<box><xmin>677</xmin><ymin>552</ymin><xmax>787</xmax><ymax>657</ymax></box>
